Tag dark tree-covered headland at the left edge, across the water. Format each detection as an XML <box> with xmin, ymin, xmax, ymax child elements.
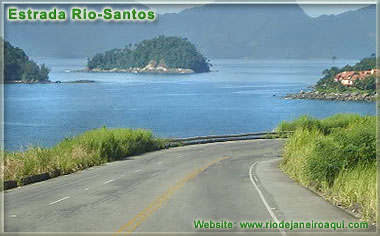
<box><xmin>3</xmin><ymin>41</ymin><xmax>50</xmax><ymax>83</ymax></box>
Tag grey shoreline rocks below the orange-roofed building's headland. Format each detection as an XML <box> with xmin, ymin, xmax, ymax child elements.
<box><xmin>285</xmin><ymin>90</ymin><xmax>377</xmax><ymax>102</ymax></box>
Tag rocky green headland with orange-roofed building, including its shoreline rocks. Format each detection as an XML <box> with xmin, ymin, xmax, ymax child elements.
<box><xmin>285</xmin><ymin>55</ymin><xmax>379</xmax><ymax>101</ymax></box>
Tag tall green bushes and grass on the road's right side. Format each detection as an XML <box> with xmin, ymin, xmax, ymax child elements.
<box><xmin>277</xmin><ymin>114</ymin><xmax>377</xmax><ymax>221</ymax></box>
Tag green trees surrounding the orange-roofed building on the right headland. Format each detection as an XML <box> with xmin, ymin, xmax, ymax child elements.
<box><xmin>315</xmin><ymin>55</ymin><xmax>376</xmax><ymax>95</ymax></box>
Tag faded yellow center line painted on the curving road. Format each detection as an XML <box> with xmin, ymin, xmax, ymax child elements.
<box><xmin>113</xmin><ymin>157</ymin><xmax>231</xmax><ymax>236</ymax></box>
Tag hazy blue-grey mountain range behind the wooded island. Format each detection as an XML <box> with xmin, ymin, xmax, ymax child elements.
<box><xmin>5</xmin><ymin>4</ymin><xmax>376</xmax><ymax>58</ymax></box>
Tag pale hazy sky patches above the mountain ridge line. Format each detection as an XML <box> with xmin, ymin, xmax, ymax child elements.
<box><xmin>147</xmin><ymin>4</ymin><xmax>367</xmax><ymax>17</ymax></box>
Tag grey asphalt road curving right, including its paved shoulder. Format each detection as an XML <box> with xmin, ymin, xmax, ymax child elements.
<box><xmin>4</xmin><ymin>140</ymin><xmax>372</xmax><ymax>235</ymax></box>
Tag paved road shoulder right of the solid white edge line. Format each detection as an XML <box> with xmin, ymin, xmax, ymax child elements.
<box><xmin>253</xmin><ymin>158</ymin><xmax>368</xmax><ymax>231</ymax></box>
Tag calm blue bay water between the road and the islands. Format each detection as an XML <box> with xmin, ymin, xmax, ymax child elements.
<box><xmin>4</xmin><ymin>58</ymin><xmax>376</xmax><ymax>150</ymax></box>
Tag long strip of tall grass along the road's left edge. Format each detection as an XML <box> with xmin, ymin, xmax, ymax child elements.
<box><xmin>4</xmin><ymin>128</ymin><xmax>166</xmax><ymax>184</ymax></box>
